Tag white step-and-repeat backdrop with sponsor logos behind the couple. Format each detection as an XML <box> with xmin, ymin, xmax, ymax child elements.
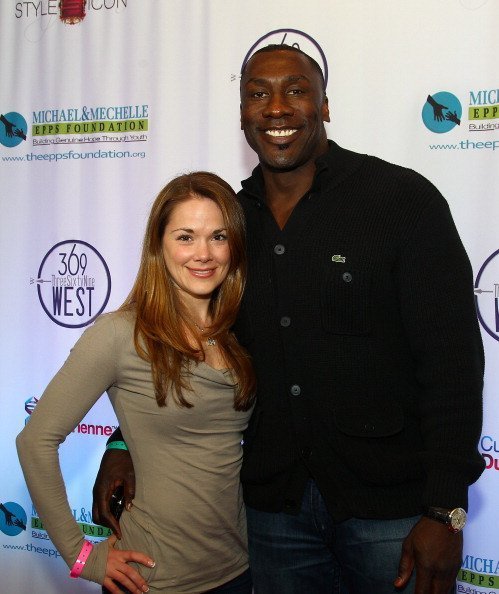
<box><xmin>0</xmin><ymin>0</ymin><xmax>499</xmax><ymax>594</ymax></box>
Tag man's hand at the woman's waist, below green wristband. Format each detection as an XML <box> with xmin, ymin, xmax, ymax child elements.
<box><xmin>92</xmin><ymin>450</ymin><xmax>135</xmax><ymax>540</ymax></box>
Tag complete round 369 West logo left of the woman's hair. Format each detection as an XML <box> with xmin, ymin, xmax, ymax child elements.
<box><xmin>30</xmin><ymin>239</ymin><xmax>111</xmax><ymax>328</ymax></box>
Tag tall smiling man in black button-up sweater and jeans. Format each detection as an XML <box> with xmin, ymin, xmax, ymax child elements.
<box><xmin>94</xmin><ymin>46</ymin><xmax>483</xmax><ymax>594</ymax></box>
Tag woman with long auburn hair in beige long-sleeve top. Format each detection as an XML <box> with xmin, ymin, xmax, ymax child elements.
<box><xmin>17</xmin><ymin>172</ymin><xmax>255</xmax><ymax>594</ymax></box>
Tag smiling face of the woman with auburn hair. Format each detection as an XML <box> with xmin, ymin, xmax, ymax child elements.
<box><xmin>163</xmin><ymin>195</ymin><xmax>230</xmax><ymax>303</ymax></box>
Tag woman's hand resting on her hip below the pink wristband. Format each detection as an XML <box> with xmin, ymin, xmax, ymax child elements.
<box><xmin>103</xmin><ymin>532</ymin><xmax>154</xmax><ymax>594</ymax></box>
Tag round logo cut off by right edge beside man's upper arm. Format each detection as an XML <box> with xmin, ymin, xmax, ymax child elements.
<box><xmin>475</xmin><ymin>250</ymin><xmax>499</xmax><ymax>341</ymax></box>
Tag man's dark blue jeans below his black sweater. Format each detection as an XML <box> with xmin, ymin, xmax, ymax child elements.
<box><xmin>246</xmin><ymin>481</ymin><xmax>419</xmax><ymax>594</ymax></box>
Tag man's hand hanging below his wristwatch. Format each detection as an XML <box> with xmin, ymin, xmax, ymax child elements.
<box><xmin>394</xmin><ymin>516</ymin><xmax>463</xmax><ymax>594</ymax></box>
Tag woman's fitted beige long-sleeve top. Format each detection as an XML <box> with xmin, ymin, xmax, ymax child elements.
<box><xmin>17</xmin><ymin>312</ymin><xmax>250</xmax><ymax>593</ymax></box>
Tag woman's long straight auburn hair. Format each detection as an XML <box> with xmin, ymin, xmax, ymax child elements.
<box><xmin>119</xmin><ymin>171</ymin><xmax>256</xmax><ymax>410</ymax></box>
